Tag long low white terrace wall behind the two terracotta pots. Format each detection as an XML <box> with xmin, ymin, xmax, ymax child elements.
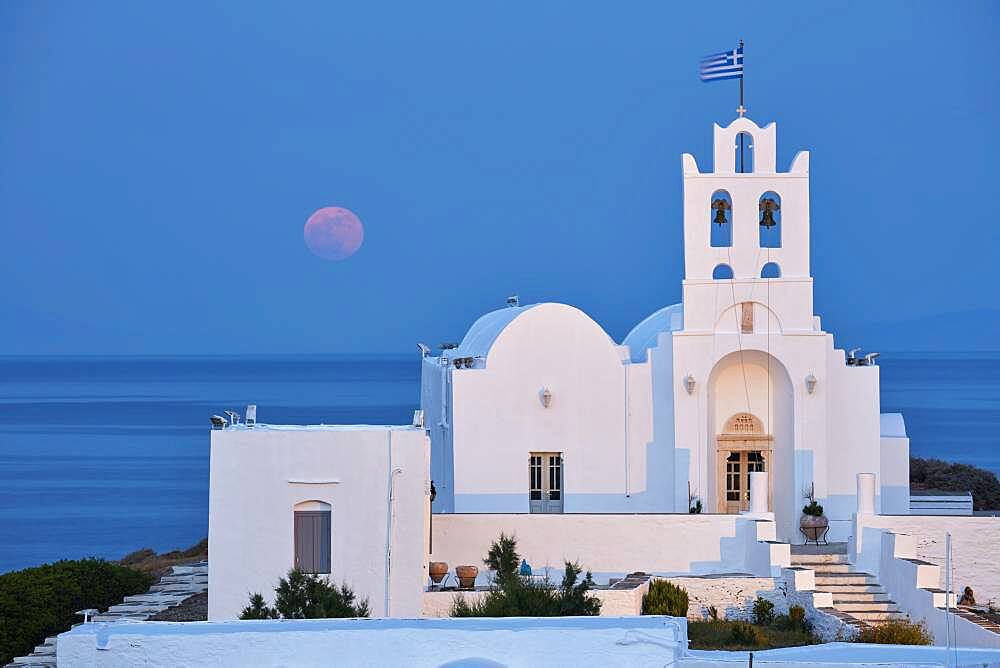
<box><xmin>431</xmin><ymin>514</ymin><xmax>770</xmax><ymax>584</ymax></box>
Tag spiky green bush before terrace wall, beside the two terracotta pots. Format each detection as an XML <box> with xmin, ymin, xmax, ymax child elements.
<box><xmin>451</xmin><ymin>534</ymin><xmax>601</xmax><ymax>617</ymax></box>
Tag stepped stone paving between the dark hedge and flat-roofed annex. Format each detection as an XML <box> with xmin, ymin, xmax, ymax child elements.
<box><xmin>5</xmin><ymin>561</ymin><xmax>208</xmax><ymax>668</ymax></box>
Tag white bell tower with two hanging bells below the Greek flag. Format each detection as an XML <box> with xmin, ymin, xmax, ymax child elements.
<box><xmin>681</xmin><ymin>117</ymin><xmax>815</xmax><ymax>331</ymax></box>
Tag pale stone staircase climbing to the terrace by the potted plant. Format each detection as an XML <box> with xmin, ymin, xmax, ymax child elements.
<box><xmin>792</xmin><ymin>543</ymin><xmax>906</xmax><ymax>626</ymax></box>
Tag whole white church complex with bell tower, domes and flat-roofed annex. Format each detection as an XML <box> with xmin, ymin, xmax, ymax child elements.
<box><xmin>209</xmin><ymin>117</ymin><xmax>1000</xmax><ymax>648</ymax></box>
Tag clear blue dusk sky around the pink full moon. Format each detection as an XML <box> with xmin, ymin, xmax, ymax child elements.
<box><xmin>0</xmin><ymin>1</ymin><xmax>1000</xmax><ymax>354</ymax></box>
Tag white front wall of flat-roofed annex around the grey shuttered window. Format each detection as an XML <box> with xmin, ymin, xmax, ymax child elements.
<box><xmin>208</xmin><ymin>425</ymin><xmax>429</xmax><ymax>620</ymax></box>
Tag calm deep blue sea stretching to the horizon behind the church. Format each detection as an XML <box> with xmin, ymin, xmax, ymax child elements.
<box><xmin>0</xmin><ymin>352</ymin><xmax>1000</xmax><ymax>573</ymax></box>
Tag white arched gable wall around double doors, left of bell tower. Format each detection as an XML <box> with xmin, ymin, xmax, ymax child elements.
<box><xmin>446</xmin><ymin>304</ymin><xmax>662</xmax><ymax>513</ymax></box>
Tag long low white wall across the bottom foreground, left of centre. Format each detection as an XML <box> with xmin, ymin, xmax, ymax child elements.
<box><xmin>58</xmin><ymin>616</ymin><xmax>687</xmax><ymax>668</ymax></box>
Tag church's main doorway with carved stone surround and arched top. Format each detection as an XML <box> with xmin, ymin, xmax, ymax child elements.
<box><xmin>715</xmin><ymin>413</ymin><xmax>774</xmax><ymax>513</ymax></box>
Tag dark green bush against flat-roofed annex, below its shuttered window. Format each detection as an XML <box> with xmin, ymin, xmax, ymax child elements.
<box><xmin>240</xmin><ymin>568</ymin><xmax>371</xmax><ymax>619</ymax></box>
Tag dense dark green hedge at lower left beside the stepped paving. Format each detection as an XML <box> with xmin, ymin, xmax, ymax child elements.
<box><xmin>0</xmin><ymin>559</ymin><xmax>153</xmax><ymax>665</ymax></box>
